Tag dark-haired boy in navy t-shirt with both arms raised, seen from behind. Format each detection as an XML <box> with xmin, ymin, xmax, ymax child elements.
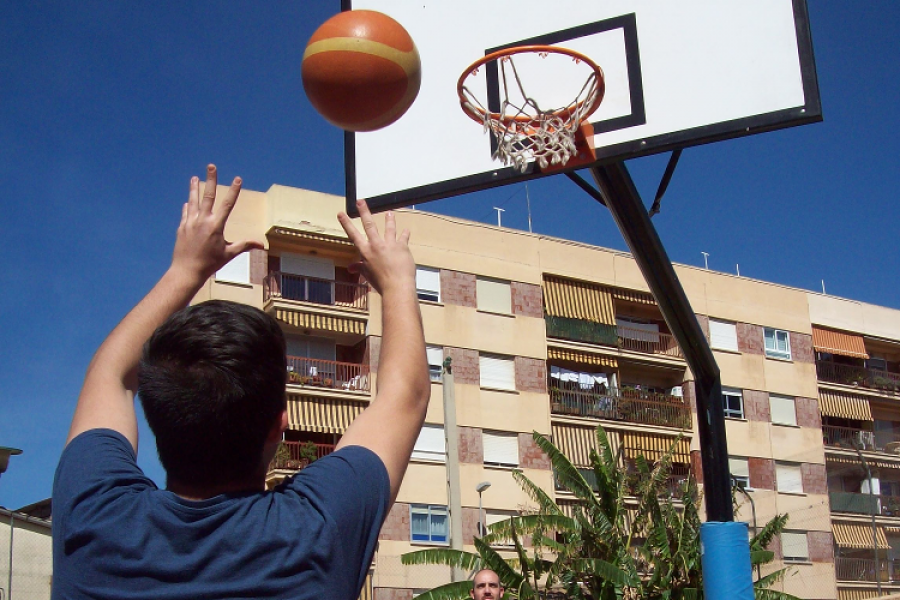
<box><xmin>53</xmin><ymin>165</ymin><xmax>430</xmax><ymax>600</ymax></box>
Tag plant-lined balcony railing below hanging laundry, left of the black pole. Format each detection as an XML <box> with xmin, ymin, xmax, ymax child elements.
<box><xmin>550</xmin><ymin>384</ymin><xmax>691</xmax><ymax>429</ymax></box>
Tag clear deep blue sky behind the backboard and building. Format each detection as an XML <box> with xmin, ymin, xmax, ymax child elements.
<box><xmin>0</xmin><ymin>0</ymin><xmax>900</xmax><ymax>508</ymax></box>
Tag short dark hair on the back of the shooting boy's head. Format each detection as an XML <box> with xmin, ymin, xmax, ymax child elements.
<box><xmin>138</xmin><ymin>300</ymin><xmax>287</xmax><ymax>486</ymax></box>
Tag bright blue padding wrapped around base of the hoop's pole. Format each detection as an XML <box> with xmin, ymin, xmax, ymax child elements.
<box><xmin>700</xmin><ymin>521</ymin><xmax>753</xmax><ymax>600</ymax></box>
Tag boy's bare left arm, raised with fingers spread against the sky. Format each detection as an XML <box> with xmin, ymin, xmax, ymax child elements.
<box><xmin>66</xmin><ymin>165</ymin><xmax>262</xmax><ymax>452</ymax></box>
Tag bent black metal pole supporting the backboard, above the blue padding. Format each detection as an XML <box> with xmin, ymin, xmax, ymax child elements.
<box><xmin>591</xmin><ymin>162</ymin><xmax>734</xmax><ymax>522</ymax></box>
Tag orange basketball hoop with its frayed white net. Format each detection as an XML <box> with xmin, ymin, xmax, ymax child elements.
<box><xmin>456</xmin><ymin>46</ymin><xmax>606</xmax><ymax>173</ymax></box>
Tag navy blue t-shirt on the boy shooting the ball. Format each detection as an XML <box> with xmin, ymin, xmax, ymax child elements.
<box><xmin>53</xmin><ymin>429</ymin><xmax>390</xmax><ymax>600</ymax></box>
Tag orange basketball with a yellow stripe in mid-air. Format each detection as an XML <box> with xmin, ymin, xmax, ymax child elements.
<box><xmin>301</xmin><ymin>10</ymin><xmax>422</xmax><ymax>131</ymax></box>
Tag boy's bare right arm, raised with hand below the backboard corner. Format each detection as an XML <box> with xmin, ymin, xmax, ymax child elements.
<box><xmin>338</xmin><ymin>200</ymin><xmax>431</xmax><ymax>503</ymax></box>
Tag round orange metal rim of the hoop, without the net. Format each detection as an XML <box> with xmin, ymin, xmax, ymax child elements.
<box><xmin>456</xmin><ymin>45</ymin><xmax>606</xmax><ymax>124</ymax></box>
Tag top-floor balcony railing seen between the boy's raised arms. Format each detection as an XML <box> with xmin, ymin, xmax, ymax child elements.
<box><xmin>263</xmin><ymin>271</ymin><xmax>369</xmax><ymax>310</ymax></box>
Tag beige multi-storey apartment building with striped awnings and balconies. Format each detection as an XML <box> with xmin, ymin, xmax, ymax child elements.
<box><xmin>196</xmin><ymin>186</ymin><xmax>900</xmax><ymax>600</ymax></box>
